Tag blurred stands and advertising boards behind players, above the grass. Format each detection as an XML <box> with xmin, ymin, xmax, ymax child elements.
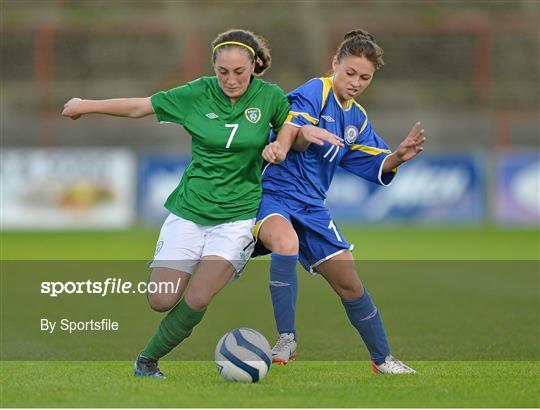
<box><xmin>0</xmin><ymin>0</ymin><xmax>540</xmax><ymax>229</ymax></box>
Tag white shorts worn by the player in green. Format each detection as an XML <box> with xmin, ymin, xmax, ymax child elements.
<box><xmin>150</xmin><ymin>213</ymin><xmax>255</xmax><ymax>274</ymax></box>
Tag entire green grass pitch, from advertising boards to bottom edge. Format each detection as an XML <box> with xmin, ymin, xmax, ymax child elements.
<box><xmin>0</xmin><ymin>227</ymin><xmax>540</xmax><ymax>407</ymax></box>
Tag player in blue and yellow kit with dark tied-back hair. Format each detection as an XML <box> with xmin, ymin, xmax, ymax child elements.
<box><xmin>254</xmin><ymin>30</ymin><xmax>425</xmax><ymax>374</ymax></box>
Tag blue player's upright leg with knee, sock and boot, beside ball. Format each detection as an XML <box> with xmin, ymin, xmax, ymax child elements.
<box><xmin>258</xmin><ymin>215</ymin><xmax>299</xmax><ymax>364</ymax></box>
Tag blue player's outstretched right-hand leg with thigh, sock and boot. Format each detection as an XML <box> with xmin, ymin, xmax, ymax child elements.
<box><xmin>317</xmin><ymin>251</ymin><xmax>415</xmax><ymax>374</ymax></box>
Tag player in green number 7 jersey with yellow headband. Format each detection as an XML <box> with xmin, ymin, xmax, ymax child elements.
<box><xmin>62</xmin><ymin>30</ymin><xmax>337</xmax><ymax>378</ymax></box>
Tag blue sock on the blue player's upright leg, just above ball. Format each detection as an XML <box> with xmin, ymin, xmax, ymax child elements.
<box><xmin>270</xmin><ymin>253</ymin><xmax>298</xmax><ymax>336</ymax></box>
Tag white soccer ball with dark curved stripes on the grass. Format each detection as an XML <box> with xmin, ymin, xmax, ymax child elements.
<box><xmin>215</xmin><ymin>327</ymin><xmax>272</xmax><ymax>383</ymax></box>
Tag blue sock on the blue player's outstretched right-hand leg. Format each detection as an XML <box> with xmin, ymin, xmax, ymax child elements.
<box><xmin>341</xmin><ymin>289</ymin><xmax>390</xmax><ymax>364</ymax></box>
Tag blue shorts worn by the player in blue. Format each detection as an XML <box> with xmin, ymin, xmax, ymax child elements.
<box><xmin>252</xmin><ymin>192</ymin><xmax>353</xmax><ymax>273</ymax></box>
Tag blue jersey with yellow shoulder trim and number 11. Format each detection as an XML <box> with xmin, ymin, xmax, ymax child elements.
<box><xmin>263</xmin><ymin>77</ymin><xmax>395</xmax><ymax>205</ymax></box>
